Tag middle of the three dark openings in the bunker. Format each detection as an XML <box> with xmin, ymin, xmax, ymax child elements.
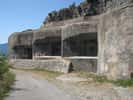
<box><xmin>33</xmin><ymin>37</ymin><xmax>61</xmax><ymax>57</ymax></box>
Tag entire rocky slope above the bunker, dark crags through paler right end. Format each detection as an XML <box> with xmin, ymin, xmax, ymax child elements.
<box><xmin>43</xmin><ymin>0</ymin><xmax>133</xmax><ymax>24</ymax></box>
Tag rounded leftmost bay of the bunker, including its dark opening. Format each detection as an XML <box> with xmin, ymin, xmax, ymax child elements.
<box><xmin>8</xmin><ymin>30</ymin><xmax>33</xmax><ymax>59</ymax></box>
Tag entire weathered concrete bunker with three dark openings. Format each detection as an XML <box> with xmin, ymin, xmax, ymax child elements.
<box><xmin>9</xmin><ymin>0</ymin><xmax>133</xmax><ymax>79</ymax></box>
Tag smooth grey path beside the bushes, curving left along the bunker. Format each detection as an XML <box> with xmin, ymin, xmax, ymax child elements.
<box><xmin>6</xmin><ymin>71</ymin><xmax>79</xmax><ymax>100</ymax></box>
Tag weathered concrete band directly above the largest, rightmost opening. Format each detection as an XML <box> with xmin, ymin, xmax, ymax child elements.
<box><xmin>62</xmin><ymin>16</ymin><xmax>98</xmax><ymax>40</ymax></box>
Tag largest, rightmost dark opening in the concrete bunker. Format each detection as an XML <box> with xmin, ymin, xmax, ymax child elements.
<box><xmin>63</xmin><ymin>33</ymin><xmax>98</xmax><ymax>57</ymax></box>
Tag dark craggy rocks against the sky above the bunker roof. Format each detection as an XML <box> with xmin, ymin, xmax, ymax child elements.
<box><xmin>44</xmin><ymin>0</ymin><xmax>99</xmax><ymax>24</ymax></box>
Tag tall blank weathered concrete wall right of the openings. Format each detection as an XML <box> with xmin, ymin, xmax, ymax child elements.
<box><xmin>98</xmin><ymin>5</ymin><xmax>133</xmax><ymax>79</ymax></box>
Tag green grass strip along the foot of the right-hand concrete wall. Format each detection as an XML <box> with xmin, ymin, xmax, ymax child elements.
<box><xmin>78</xmin><ymin>72</ymin><xmax>133</xmax><ymax>87</ymax></box>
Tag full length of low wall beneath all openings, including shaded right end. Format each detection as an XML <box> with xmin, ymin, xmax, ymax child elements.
<box><xmin>9</xmin><ymin>58</ymin><xmax>97</xmax><ymax>73</ymax></box>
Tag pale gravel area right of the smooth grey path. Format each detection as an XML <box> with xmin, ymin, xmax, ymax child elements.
<box><xmin>54</xmin><ymin>74</ymin><xmax>133</xmax><ymax>100</ymax></box>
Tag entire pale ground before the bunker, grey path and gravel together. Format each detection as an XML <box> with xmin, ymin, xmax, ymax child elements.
<box><xmin>6</xmin><ymin>71</ymin><xmax>133</xmax><ymax>100</ymax></box>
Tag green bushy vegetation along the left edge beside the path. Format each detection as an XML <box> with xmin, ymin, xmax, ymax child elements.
<box><xmin>0</xmin><ymin>57</ymin><xmax>15</xmax><ymax>100</ymax></box>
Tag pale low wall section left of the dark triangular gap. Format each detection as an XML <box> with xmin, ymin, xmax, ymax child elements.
<box><xmin>9</xmin><ymin>59</ymin><xmax>70</xmax><ymax>73</ymax></box>
